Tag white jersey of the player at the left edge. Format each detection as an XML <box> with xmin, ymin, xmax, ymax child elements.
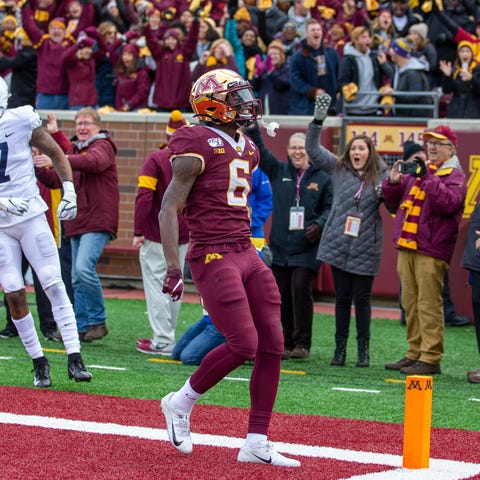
<box><xmin>0</xmin><ymin>106</ymin><xmax>48</xmax><ymax>228</ymax></box>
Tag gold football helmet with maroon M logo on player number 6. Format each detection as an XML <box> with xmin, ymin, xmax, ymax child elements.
<box><xmin>190</xmin><ymin>68</ymin><xmax>262</xmax><ymax>126</ymax></box>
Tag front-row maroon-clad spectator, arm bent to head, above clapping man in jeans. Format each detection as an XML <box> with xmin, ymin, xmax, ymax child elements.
<box><xmin>63</xmin><ymin>37</ymin><xmax>105</xmax><ymax>110</ymax></box>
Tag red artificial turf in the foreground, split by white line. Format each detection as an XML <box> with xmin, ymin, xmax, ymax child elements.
<box><xmin>0</xmin><ymin>387</ymin><xmax>480</xmax><ymax>480</ymax></box>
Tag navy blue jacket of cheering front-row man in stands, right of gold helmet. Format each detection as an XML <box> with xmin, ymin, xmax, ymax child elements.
<box><xmin>288</xmin><ymin>40</ymin><xmax>340</xmax><ymax>115</ymax></box>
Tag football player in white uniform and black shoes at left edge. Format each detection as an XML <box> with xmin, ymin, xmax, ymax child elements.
<box><xmin>0</xmin><ymin>77</ymin><xmax>92</xmax><ymax>387</ymax></box>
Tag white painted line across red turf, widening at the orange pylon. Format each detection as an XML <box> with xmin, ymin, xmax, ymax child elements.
<box><xmin>0</xmin><ymin>412</ymin><xmax>480</xmax><ymax>480</ymax></box>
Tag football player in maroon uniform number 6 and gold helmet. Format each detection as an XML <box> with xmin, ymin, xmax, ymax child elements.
<box><xmin>160</xmin><ymin>69</ymin><xmax>300</xmax><ymax>467</ymax></box>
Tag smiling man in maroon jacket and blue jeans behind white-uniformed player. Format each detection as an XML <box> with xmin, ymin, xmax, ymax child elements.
<box><xmin>37</xmin><ymin>107</ymin><xmax>119</xmax><ymax>342</ymax></box>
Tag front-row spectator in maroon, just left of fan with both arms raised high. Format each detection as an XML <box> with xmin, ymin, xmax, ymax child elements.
<box><xmin>110</xmin><ymin>43</ymin><xmax>150</xmax><ymax>112</ymax></box>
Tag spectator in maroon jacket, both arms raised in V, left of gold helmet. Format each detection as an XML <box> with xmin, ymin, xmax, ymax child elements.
<box><xmin>144</xmin><ymin>9</ymin><xmax>199</xmax><ymax>111</ymax></box>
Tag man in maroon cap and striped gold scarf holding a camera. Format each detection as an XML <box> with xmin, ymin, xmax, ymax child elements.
<box><xmin>382</xmin><ymin>125</ymin><xmax>467</xmax><ymax>375</ymax></box>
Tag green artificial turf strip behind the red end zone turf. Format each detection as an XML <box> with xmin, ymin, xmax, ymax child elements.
<box><xmin>0</xmin><ymin>295</ymin><xmax>480</xmax><ymax>431</ymax></box>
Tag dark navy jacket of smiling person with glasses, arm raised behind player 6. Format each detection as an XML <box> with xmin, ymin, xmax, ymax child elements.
<box><xmin>248</xmin><ymin>126</ymin><xmax>332</xmax><ymax>271</ymax></box>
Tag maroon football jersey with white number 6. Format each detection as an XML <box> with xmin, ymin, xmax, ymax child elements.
<box><xmin>168</xmin><ymin>125</ymin><xmax>259</xmax><ymax>259</ymax></box>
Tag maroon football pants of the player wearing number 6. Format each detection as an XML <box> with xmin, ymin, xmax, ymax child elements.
<box><xmin>190</xmin><ymin>246</ymin><xmax>283</xmax><ymax>435</ymax></box>
